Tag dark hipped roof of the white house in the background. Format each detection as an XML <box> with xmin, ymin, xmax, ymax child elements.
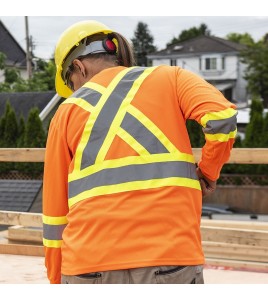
<box><xmin>148</xmin><ymin>35</ymin><xmax>246</xmax><ymax>58</ymax></box>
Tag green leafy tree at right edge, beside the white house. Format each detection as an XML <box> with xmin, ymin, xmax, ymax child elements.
<box><xmin>241</xmin><ymin>35</ymin><xmax>268</xmax><ymax>107</ymax></box>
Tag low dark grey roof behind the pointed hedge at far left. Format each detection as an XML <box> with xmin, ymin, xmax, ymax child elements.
<box><xmin>0</xmin><ymin>91</ymin><xmax>55</xmax><ymax>120</ymax></box>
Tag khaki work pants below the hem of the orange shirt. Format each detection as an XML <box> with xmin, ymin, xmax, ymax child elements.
<box><xmin>61</xmin><ymin>265</ymin><xmax>204</xmax><ymax>284</ymax></box>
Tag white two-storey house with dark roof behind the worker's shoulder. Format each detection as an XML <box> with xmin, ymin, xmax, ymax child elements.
<box><xmin>147</xmin><ymin>36</ymin><xmax>248</xmax><ymax>107</ymax></box>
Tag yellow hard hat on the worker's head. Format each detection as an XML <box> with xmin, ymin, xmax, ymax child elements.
<box><xmin>55</xmin><ymin>20</ymin><xmax>113</xmax><ymax>98</ymax></box>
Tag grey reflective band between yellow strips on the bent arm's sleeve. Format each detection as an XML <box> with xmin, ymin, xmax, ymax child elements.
<box><xmin>203</xmin><ymin>115</ymin><xmax>236</xmax><ymax>134</ymax></box>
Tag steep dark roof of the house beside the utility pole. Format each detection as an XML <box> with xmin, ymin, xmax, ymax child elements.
<box><xmin>0</xmin><ymin>20</ymin><xmax>26</xmax><ymax>67</ymax></box>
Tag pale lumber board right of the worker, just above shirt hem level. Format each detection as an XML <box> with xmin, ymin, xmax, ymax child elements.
<box><xmin>202</xmin><ymin>241</ymin><xmax>268</xmax><ymax>266</ymax></box>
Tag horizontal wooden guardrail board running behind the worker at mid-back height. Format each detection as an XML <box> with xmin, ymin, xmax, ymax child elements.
<box><xmin>0</xmin><ymin>148</ymin><xmax>268</xmax><ymax>164</ymax></box>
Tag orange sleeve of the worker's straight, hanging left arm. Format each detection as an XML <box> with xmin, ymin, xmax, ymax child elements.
<box><xmin>43</xmin><ymin>115</ymin><xmax>71</xmax><ymax>283</ymax></box>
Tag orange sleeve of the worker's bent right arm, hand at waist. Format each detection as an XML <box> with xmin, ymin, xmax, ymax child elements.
<box><xmin>177</xmin><ymin>69</ymin><xmax>237</xmax><ymax>180</ymax></box>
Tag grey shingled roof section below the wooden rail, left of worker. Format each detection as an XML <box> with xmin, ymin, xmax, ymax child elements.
<box><xmin>0</xmin><ymin>180</ymin><xmax>42</xmax><ymax>212</ymax></box>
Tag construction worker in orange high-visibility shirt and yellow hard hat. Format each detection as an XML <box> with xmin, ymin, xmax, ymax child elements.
<box><xmin>43</xmin><ymin>20</ymin><xmax>237</xmax><ymax>284</ymax></box>
